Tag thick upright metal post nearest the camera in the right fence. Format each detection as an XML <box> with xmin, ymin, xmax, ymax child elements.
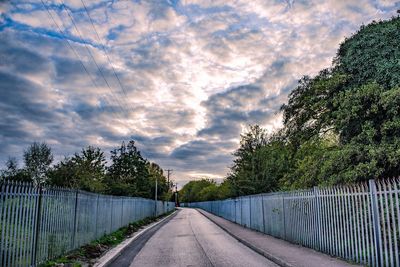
<box><xmin>369</xmin><ymin>179</ymin><xmax>383</xmax><ymax>266</ymax></box>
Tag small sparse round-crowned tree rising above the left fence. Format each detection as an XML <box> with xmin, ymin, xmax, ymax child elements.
<box><xmin>24</xmin><ymin>142</ymin><xmax>53</xmax><ymax>185</ymax></box>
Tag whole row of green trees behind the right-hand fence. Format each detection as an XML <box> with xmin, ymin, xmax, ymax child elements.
<box><xmin>180</xmin><ymin>17</ymin><xmax>400</xmax><ymax>201</ymax></box>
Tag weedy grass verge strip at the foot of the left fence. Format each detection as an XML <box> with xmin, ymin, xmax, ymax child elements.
<box><xmin>40</xmin><ymin>211</ymin><xmax>173</xmax><ymax>267</ymax></box>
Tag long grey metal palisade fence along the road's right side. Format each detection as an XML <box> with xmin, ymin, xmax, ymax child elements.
<box><xmin>184</xmin><ymin>179</ymin><xmax>400</xmax><ymax>266</ymax></box>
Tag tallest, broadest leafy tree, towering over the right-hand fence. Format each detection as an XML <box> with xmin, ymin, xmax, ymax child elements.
<box><xmin>282</xmin><ymin>17</ymin><xmax>400</xmax><ymax>187</ymax></box>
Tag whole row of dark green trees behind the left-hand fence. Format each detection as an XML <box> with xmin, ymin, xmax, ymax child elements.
<box><xmin>0</xmin><ymin>141</ymin><xmax>172</xmax><ymax>200</ymax></box>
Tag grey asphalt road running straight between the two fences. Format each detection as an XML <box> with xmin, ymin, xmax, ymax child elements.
<box><xmin>111</xmin><ymin>209</ymin><xmax>277</xmax><ymax>267</ymax></box>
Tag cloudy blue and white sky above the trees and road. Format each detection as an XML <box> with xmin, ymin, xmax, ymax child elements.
<box><xmin>0</xmin><ymin>0</ymin><xmax>400</xmax><ymax>185</ymax></box>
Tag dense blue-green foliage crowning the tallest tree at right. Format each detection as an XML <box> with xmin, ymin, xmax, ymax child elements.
<box><xmin>334</xmin><ymin>17</ymin><xmax>400</xmax><ymax>88</ymax></box>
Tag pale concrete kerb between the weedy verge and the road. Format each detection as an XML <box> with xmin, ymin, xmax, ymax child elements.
<box><xmin>93</xmin><ymin>210</ymin><xmax>178</xmax><ymax>267</ymax></box>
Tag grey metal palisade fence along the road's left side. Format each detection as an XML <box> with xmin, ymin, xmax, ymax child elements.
<box><xmin>0</xmin><ymin>181</ymin><xmax>174</xmax><ymax>267</ymax></box>
